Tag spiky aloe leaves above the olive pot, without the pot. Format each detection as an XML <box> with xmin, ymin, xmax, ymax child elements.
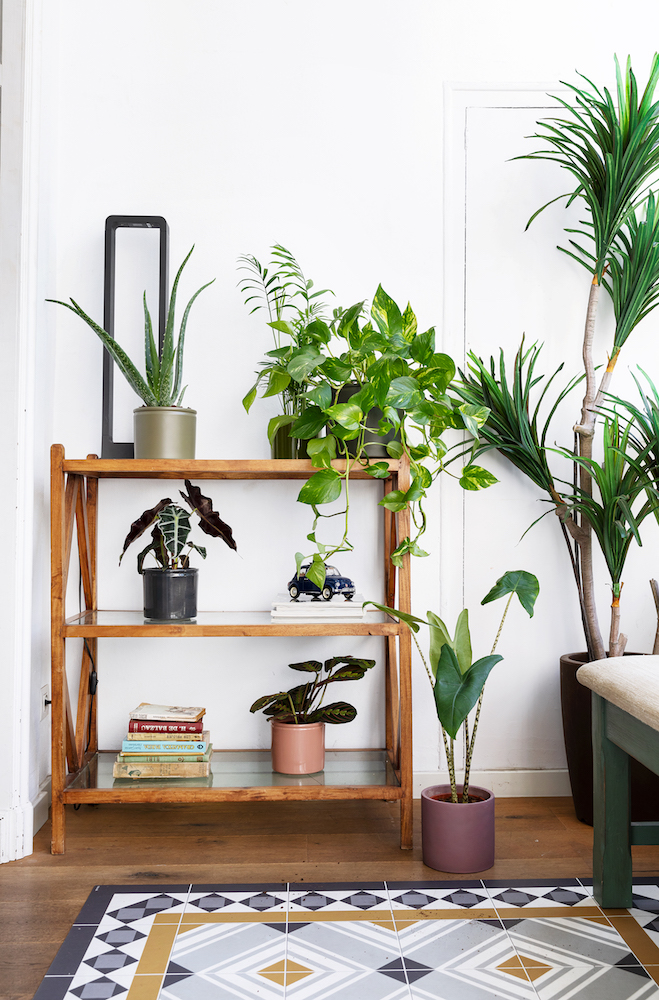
<box><xmin>46</xmin><ymin>247</ymin><xmax>215</xmax><ymax>406</ymax></box>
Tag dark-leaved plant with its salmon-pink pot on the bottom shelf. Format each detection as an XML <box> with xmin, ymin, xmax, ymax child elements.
<box><xmin>250</xmin><ymin>656</ymin><xmax>375</xmax><ymax>774</ymax></box>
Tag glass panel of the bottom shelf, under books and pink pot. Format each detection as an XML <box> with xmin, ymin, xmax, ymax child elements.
<box><xmin>66</xmin><ymin>750</ymin><xmax>399</xmax><ymax>791</ymax></box>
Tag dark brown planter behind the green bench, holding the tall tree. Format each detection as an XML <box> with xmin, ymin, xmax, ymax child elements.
<box><xmin>561</xmin><ymin>653</ymin><xmax>659</xmax><ymax>826</ymax></box>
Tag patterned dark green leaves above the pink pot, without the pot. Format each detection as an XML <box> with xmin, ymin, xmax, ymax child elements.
<box><xmin>250</xmin><ymin>656</ymin><xmax>375</xmax><ymax>725</ymax></box>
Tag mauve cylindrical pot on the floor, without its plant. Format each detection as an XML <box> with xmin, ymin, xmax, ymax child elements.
<box><xmin>421</xmin><ymin>785</ymin><xmax>494</xmax><ymax>875</ymax></box>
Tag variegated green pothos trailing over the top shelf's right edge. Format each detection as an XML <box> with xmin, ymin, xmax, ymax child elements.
<box><xmin>290</xmin><ymin>285</ymin><xmax>497</xmax><ymax>588</ymax></box>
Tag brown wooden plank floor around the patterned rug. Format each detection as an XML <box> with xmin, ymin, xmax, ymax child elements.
<box><xmin>0</xmin><ymin>798</ymin><xmax>659</xmax><ymax>1000</ymax></box>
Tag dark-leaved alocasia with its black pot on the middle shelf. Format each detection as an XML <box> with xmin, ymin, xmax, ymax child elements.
<box><xmin>119</xmin><ymin>479</ymin><xmax>236</xmax><ymax>622</ymax></box>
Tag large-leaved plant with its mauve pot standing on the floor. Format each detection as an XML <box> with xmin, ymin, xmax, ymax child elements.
<box><xmin>369</xmin><ymin>570</ymin><xmax>540</xmax><ymax>874</ymax></box>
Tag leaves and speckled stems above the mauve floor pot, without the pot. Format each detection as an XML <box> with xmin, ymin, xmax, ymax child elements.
<box><xmin>369</xmin><ymin>570</ymin><xmax>540</xmax><ymax>802</ymax></box>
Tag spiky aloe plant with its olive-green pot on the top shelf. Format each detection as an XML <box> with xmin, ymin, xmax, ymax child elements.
<box><xmin>47</xmin><ymin>247</ymin><xmax>215</xmax><ymax>459</ymax></box>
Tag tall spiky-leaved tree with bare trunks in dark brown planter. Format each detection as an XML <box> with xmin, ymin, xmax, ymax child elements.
<box><xmin>458</xmin><ymin>55</ymin><xmax>659</xmax><ymax>822</ymax></box>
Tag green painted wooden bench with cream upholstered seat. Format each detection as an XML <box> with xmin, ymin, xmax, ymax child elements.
<box><xmin>577</xmin><ymin>656</ymin><xmax>659</xmax><ymax>907</ymax></box>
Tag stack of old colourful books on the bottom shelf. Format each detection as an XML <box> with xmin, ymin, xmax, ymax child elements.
<box><xmin>112</xmin><ymin>702</ymin><xmax>213</xmax><ymax>779</ymax></box>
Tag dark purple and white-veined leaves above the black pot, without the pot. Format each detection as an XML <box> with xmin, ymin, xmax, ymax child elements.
<box><xmin>119</xmin><ymin>479</ymin><xmax>236</xmax><ymax>573</ymax></box>
